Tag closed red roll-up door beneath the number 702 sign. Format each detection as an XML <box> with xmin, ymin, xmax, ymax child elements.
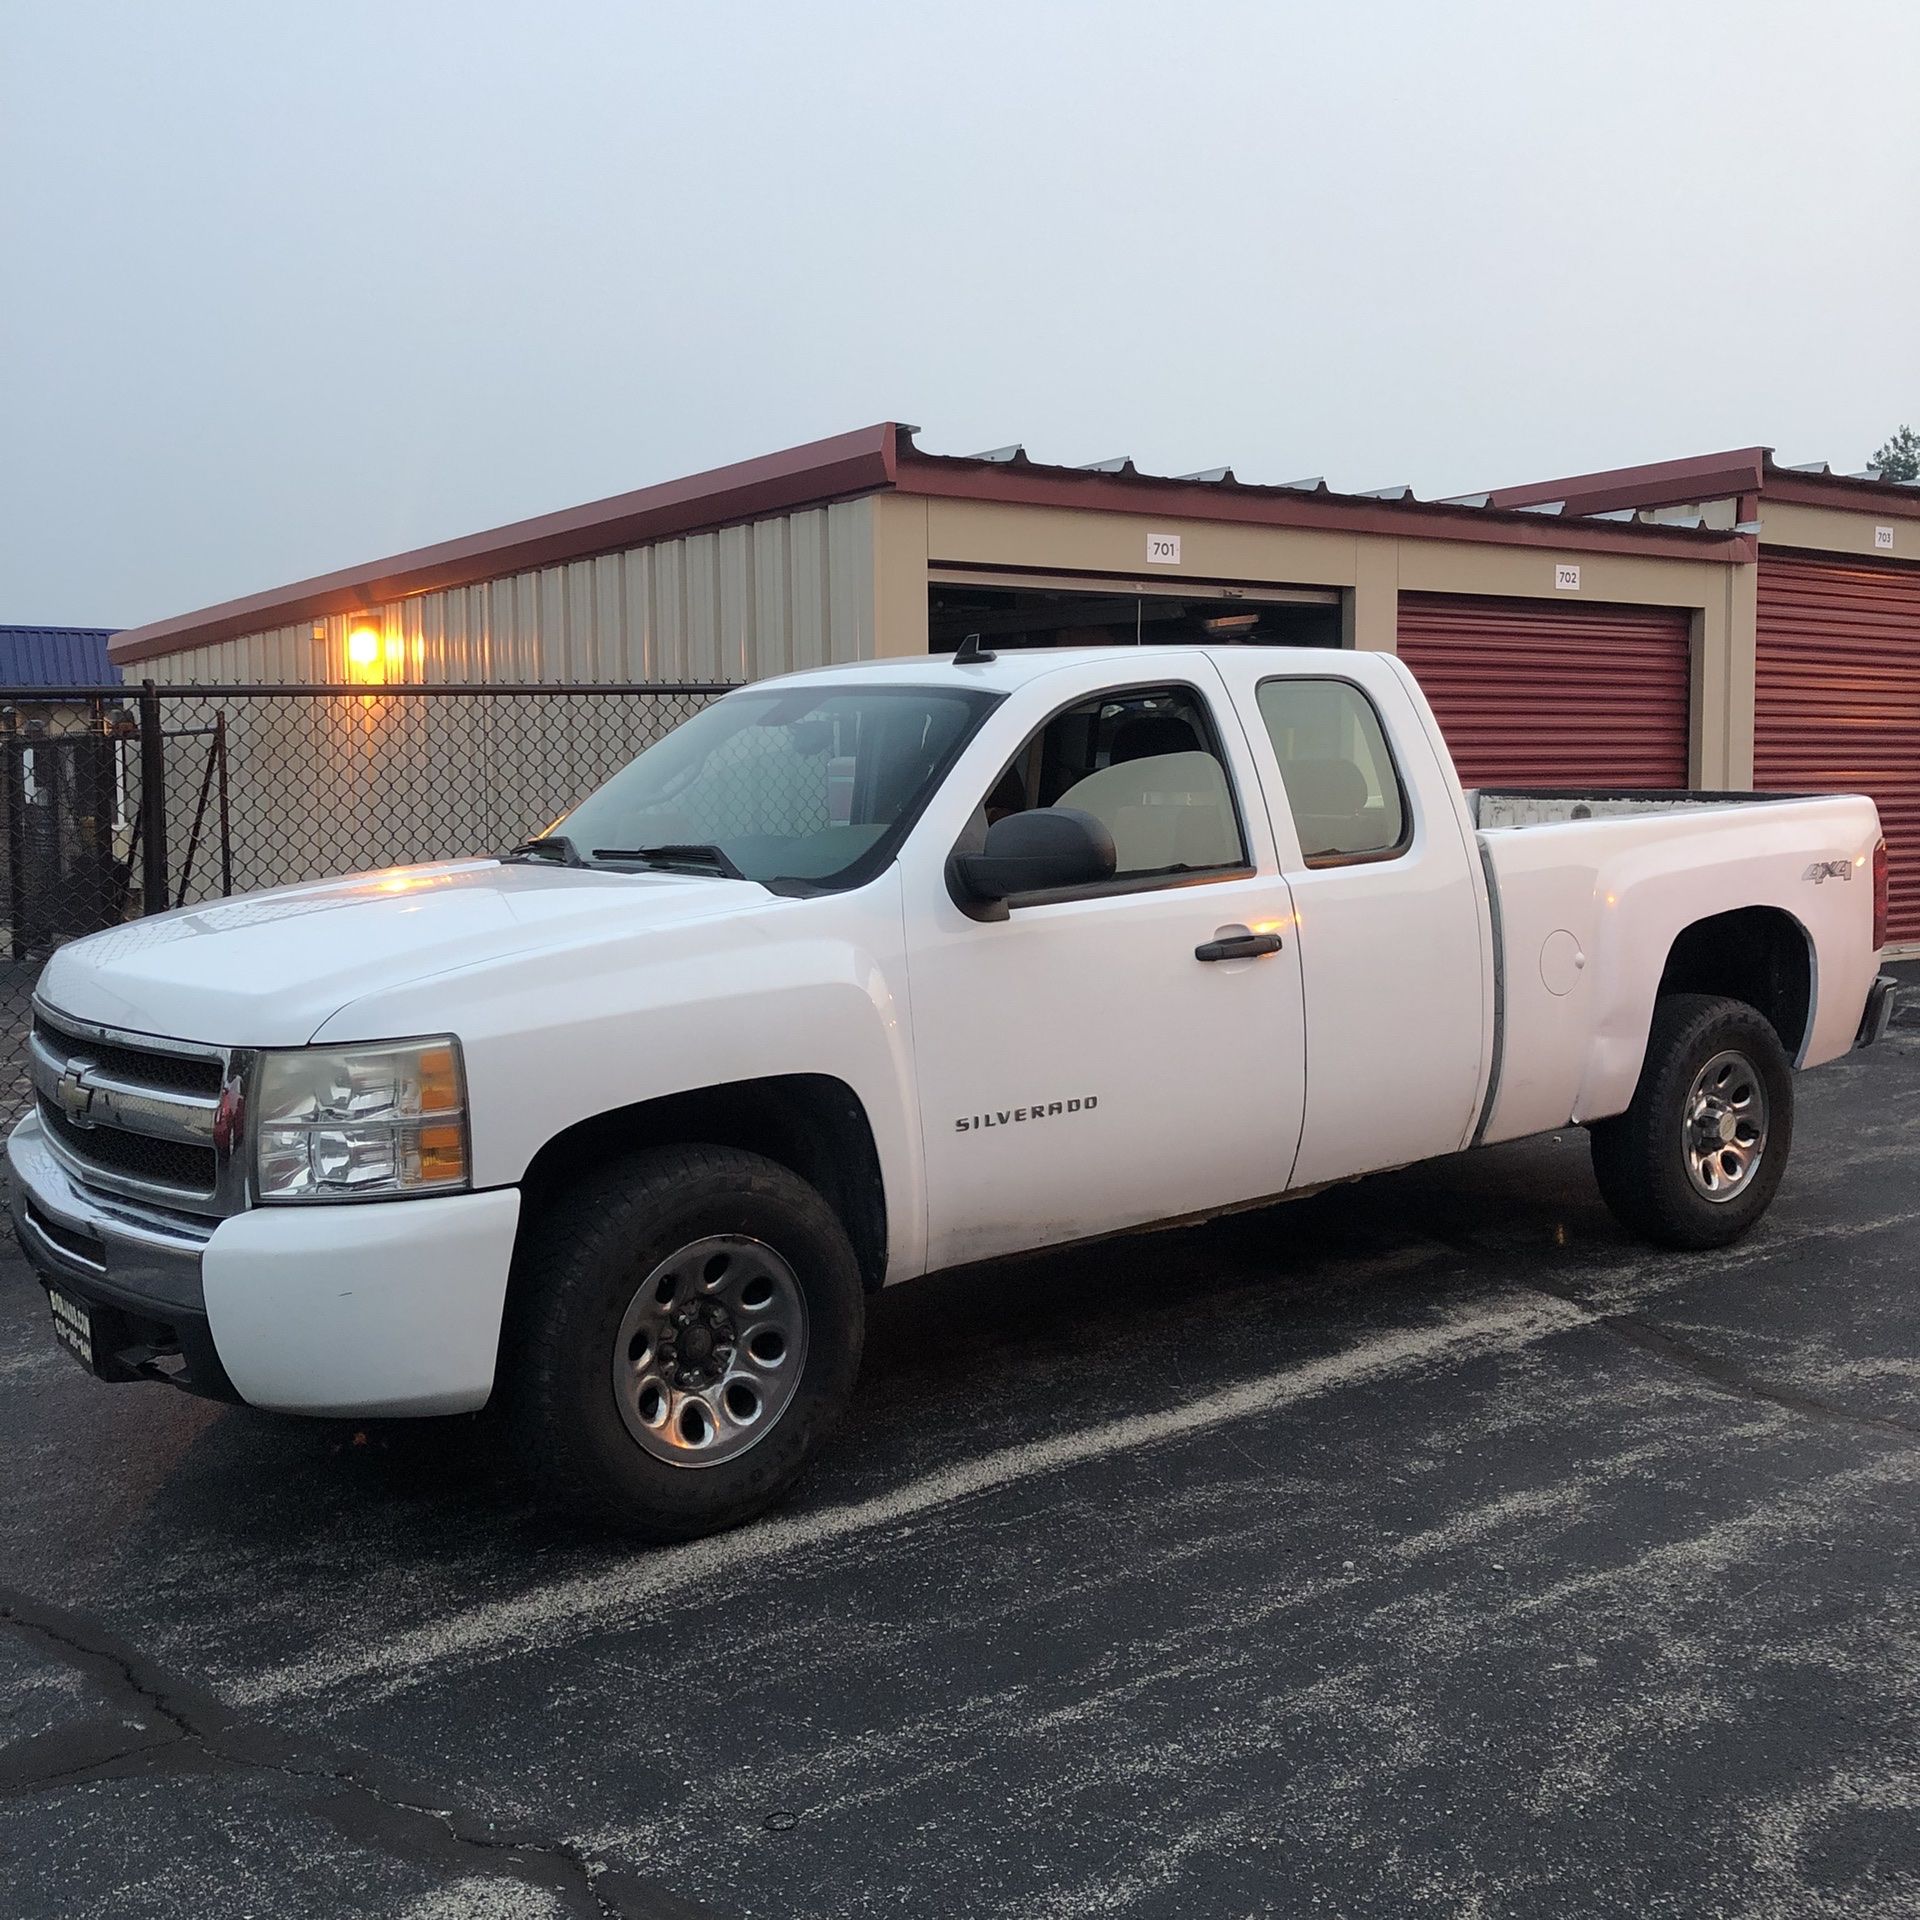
<box><xmin>1400</xmin><ymin>593</ymin><xmax>1692</xmax><ymax>787</ymax></box>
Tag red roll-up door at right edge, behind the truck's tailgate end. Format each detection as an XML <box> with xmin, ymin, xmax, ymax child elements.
<box><xmin>1753</xmin><ymin>553</ymin><xmax>1920</xmax><ymax>941</ymax></box>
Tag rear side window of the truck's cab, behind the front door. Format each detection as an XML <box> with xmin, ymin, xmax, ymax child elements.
<box><xmin>1256</xmin><ymin>678</ymin><xmax>1413</xmax><ymax>868</ymax></box>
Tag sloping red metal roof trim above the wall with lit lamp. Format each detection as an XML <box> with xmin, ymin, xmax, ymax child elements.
<box><xmin>111</xmin><ymin>420</ymin><xmax>899</xmax><ymax>666</ymax></box>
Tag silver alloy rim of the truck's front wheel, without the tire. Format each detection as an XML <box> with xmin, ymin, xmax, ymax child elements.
<box><xmin>612</xmin><ymin>1233</ymin><xmax>806</xmax><ymax>1467</ymax></box>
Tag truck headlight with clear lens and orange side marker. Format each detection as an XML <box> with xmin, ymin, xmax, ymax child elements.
<box><xmin>252</xmin><ymin>1037</ymin><xmax>468</xmax><ymax>1200</ymax></box>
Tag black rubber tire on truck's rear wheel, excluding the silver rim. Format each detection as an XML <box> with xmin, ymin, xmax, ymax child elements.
<box><xmin>1590</xmin><ymin>993</ymin><xmax>1793</xmax><ymax>1250</ymax></box>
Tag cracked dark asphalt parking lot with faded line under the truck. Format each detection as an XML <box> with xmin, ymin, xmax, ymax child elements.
<box><xmin>0</xmin><ymin>998</ymin><xmax>1920</xmax><ymax>1920</ymax></box>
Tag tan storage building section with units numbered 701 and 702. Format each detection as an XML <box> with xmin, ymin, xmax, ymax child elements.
<box><xmin>113</xmin><ymin>424</ymin><xmax>1753</xmax><ymax>785</ymax></box>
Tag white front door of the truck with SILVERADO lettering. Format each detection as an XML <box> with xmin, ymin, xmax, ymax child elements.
<box><xmin>900</xmin><ymin>657</ymin><xmax>1304</xmax><ymax>1267</ymax></box>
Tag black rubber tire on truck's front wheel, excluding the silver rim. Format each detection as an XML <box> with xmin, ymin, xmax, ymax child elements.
<box><xmin>501</xmin><ymin>1146</ymin><xmax>866</xmax><ymax>1540</ymax></box>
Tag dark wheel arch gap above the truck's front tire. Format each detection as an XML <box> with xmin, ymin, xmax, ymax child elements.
<box><xmin>520</xmin><ymin>1073</ymin><xmax>887</xmax><ymax>1292</ymax></box>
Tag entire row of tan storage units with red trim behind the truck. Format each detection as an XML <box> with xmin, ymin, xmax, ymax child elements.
<box><xmin>113</xmin><ymin>422</ymin><xmax>1920</xmax><ymax>941</ymax></box>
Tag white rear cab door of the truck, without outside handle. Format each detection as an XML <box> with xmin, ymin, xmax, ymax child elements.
<box><xmin>1219</xmin><ymin>647</ymin><xmax>1492</xmax><ymax>1187</ymax></box>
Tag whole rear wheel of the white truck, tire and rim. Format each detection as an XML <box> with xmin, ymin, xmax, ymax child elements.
<box><xmin>1590</xmin><ymin>993</ymin><xmax>1793</xmax><ymax>1248</ymax></box>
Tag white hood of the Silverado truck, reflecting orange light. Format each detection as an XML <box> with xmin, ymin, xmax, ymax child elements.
<box><xmin>38</xmin><ymin>860</ymin><xmax>764</xmax><ymax>1046</ymax></box>
